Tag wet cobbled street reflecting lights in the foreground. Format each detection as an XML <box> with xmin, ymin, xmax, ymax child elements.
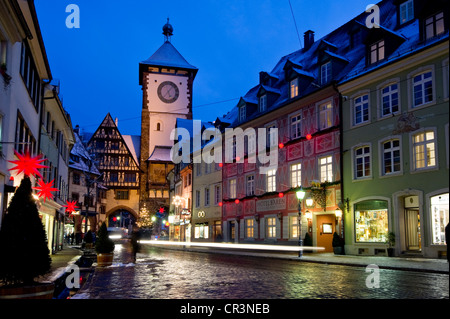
<box><xmin>74</xmin><ymin>245</ymin><xmax>449</xmax><ymax>300</ymax></box>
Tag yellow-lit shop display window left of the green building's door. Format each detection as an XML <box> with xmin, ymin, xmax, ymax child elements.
<box><xmin>354</xmin><ymin>200</ymin><xmax>389</xmax><ymax>243</ymax></box>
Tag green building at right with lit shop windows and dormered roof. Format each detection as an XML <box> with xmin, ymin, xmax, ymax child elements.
<box><xmin>339</xmin><ymin>0</ymin><xmax>449</xmax><ymax>258</ymax></box>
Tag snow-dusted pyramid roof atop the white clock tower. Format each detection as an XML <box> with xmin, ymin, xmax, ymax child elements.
<box><xmin>141</xmin><ymin>41</ymin><xmax>198</xmax><ymax>71</ymax></box>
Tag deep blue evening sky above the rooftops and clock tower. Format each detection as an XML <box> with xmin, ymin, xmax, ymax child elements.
<box><xmin>35</xmin><ymin>0</ymin><xmax>370</xmax><ymax>135</ymax></box>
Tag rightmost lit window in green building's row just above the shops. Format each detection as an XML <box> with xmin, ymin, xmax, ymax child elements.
<box><xmin>413</xmin><ymin>131</ymin><xmax>436</xmax><ymax>169</ymax></box>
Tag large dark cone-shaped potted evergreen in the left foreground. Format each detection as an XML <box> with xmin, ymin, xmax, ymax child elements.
<box><xmin>0</xmin><ymin>176</ymin><xmax>54</xmax><ymax>299</ymax></box>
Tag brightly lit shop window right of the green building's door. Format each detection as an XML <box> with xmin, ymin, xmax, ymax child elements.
<box><xmin>431</xmin><ymin>193</ymin><xmax>449</xmax><ymax>245</ymax></box>
